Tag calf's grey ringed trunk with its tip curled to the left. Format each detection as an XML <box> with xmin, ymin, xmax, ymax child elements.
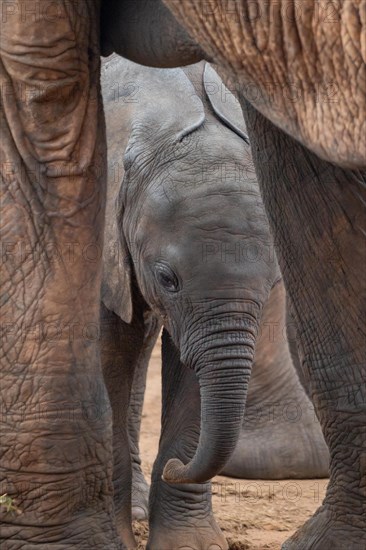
<box><xmin>163</xmin><ymin>319</ymin><xmax>257</xmax><ymax>483</ymax></box>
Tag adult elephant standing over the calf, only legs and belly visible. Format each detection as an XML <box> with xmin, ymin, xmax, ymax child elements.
<box><xmin>0</xmin><ymin>0</ymin><xmax>366</xmax><ymax>549</ymax></box>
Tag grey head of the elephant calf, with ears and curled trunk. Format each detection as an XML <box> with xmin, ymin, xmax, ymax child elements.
<box><xmin>102</xmin><ymin>56</ymin><xmax>279</xmax><ymax>482</ymax></box>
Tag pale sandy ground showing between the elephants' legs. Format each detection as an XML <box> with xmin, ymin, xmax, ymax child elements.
<box><xmin>134</xmin><ymin>344</ymin><xmax>327</xmax><ymax>550</ymax></box>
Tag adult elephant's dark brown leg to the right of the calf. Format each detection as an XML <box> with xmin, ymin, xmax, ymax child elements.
<box><xmin>242</xmin><ymin>101</ymin><xmax>366</xmax><ymax>550</ymax></box>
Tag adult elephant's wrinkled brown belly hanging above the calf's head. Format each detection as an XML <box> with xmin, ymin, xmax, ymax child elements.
<box><xmin>102</xmin><ymin>0</ymin><xmax>366</xmax><ymax>169</ymax></box>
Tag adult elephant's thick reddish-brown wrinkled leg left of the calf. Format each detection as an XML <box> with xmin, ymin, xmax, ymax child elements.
<box><xmin>0</xmin><ymin>1</ymin><xmax>122</xmax><ymax>550</ymax></box>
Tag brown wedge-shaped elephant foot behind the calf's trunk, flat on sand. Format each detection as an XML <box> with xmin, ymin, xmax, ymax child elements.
<box><xmin>222</xmin><ymin>282</ymin><xmax>329</xmax><ymax>479</ymax></box>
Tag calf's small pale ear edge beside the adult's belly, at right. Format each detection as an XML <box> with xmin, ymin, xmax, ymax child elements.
<box><xmin>203</xmin><ymin>63</ymin><xmax>249</xmax><ymax>145</ymax></box>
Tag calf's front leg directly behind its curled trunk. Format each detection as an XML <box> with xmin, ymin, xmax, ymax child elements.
<box><xmin>147</xmin><ymin>330</ymin><xmax>228</xmax><ymax>550</ymax></box>
